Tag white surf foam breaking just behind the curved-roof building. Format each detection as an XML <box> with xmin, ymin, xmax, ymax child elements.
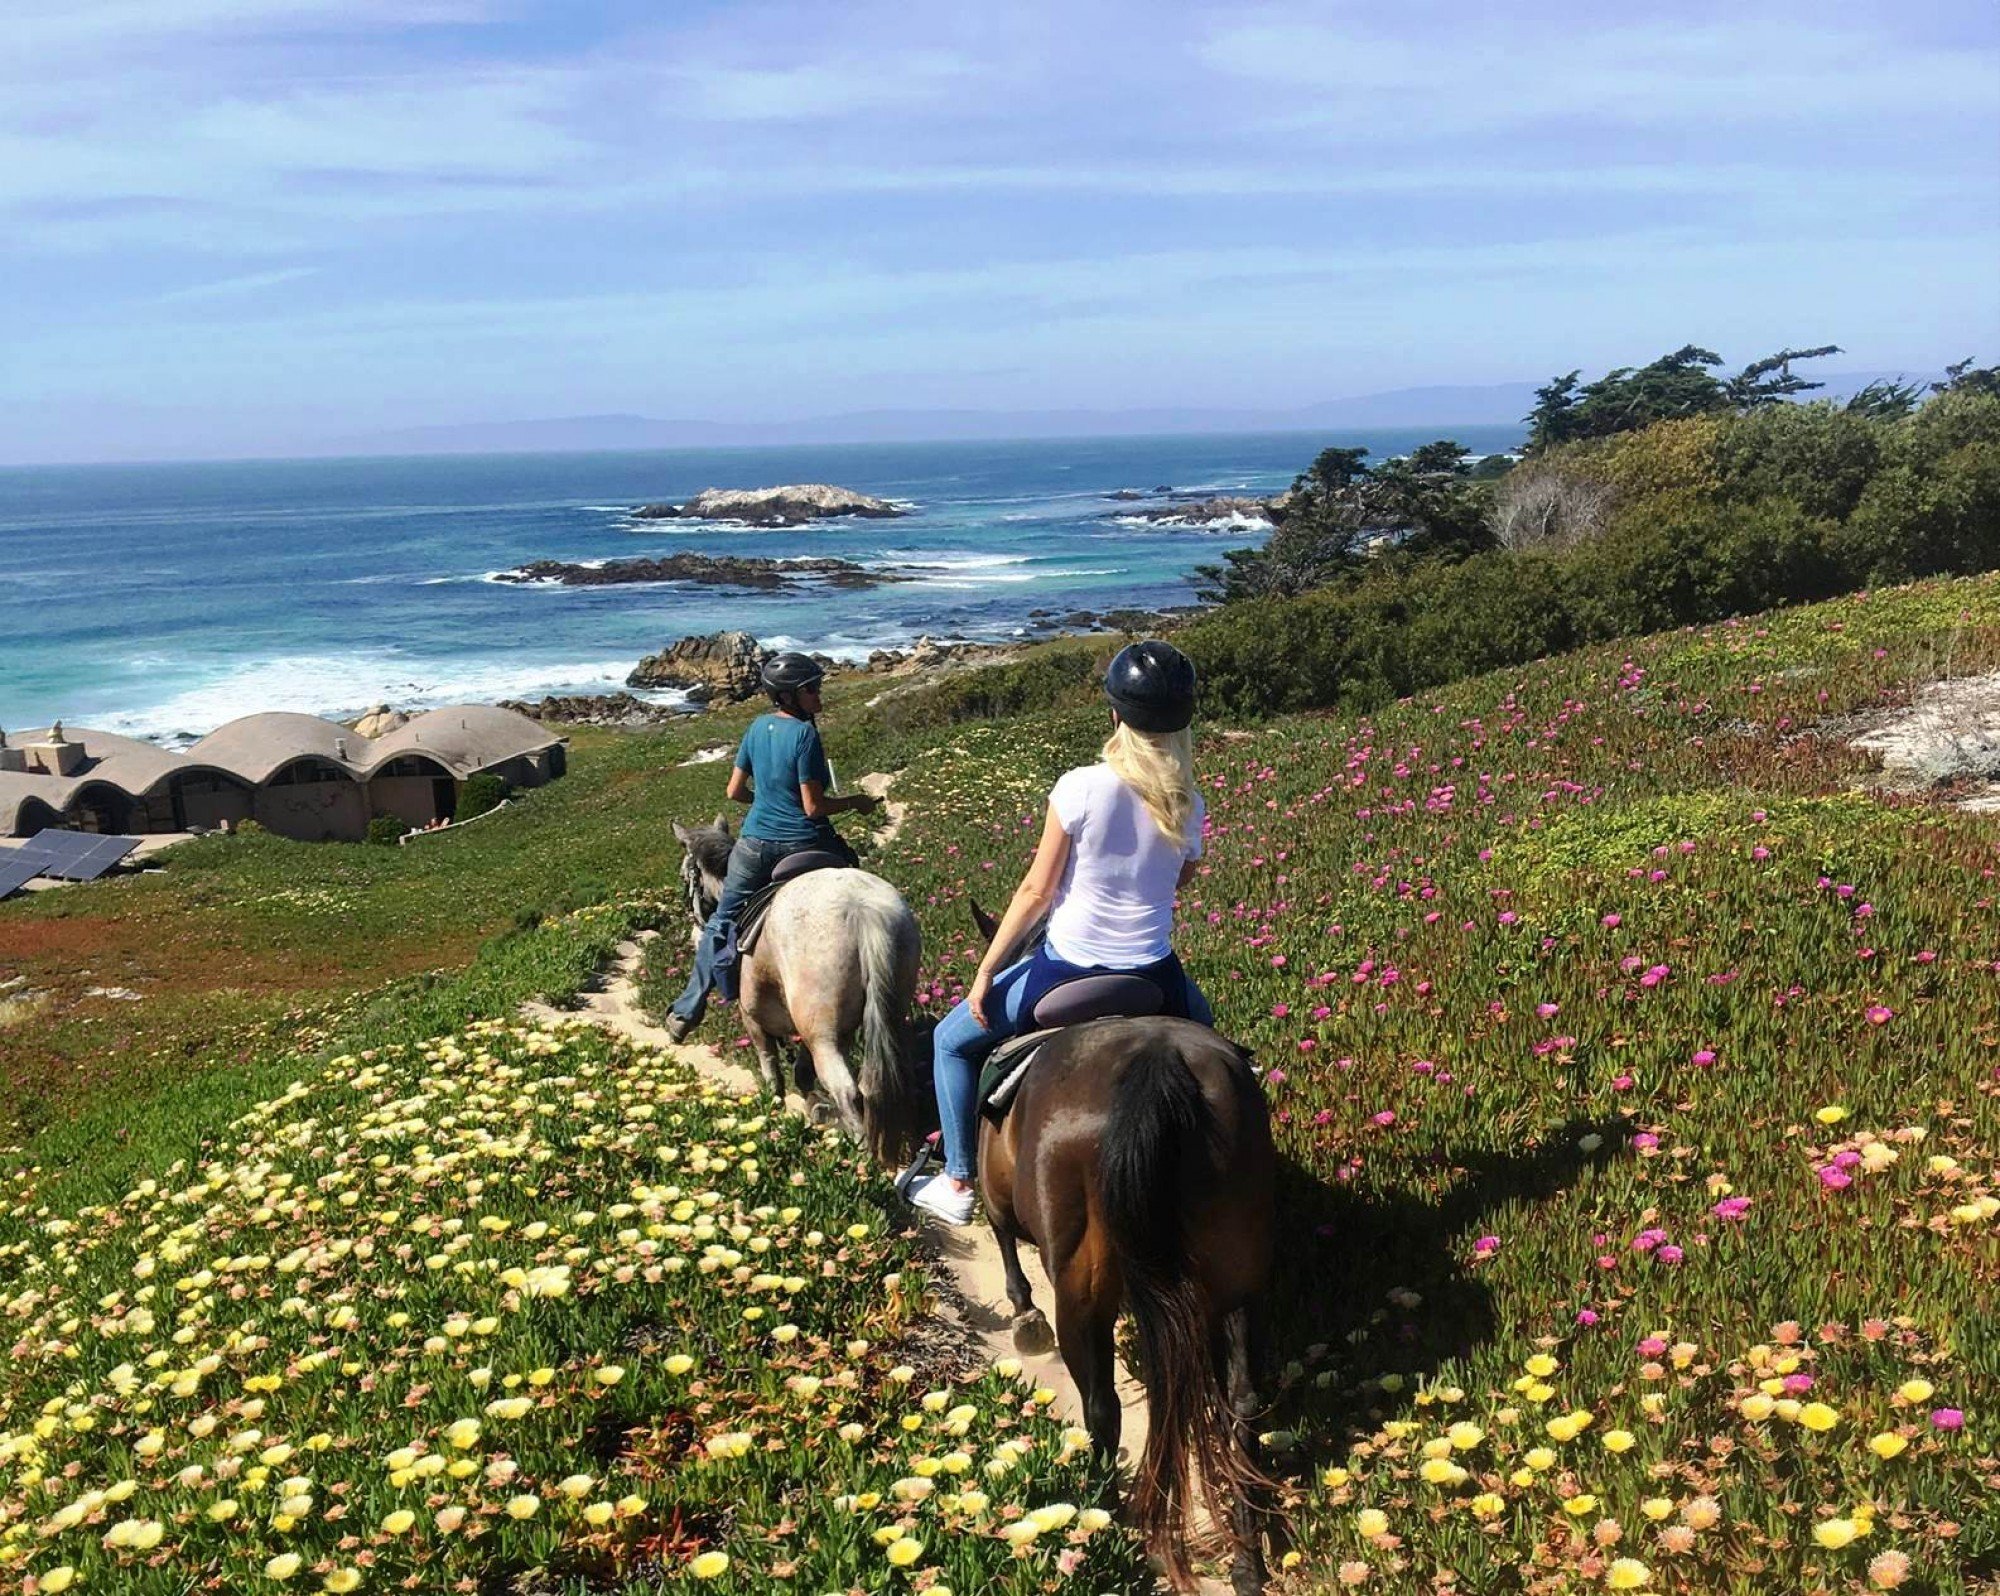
<box><xmin>80</xmin><ymin>652</ymin><xmax>682</xmax><ymax>736</ymax></box>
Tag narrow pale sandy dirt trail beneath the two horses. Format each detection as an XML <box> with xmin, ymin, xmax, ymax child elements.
<box><xmin>522</xmin><ymin>772</ymin><xmax>1228</xmax><ymax>1596</ymax></box>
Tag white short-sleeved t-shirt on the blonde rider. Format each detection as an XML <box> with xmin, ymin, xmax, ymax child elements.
<box><xmin>1048</xmin><ymin>764</ymin><xmax>1204</xmax><ymax>970</ymax></box>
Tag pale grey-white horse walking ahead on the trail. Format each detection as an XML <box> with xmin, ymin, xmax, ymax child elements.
<box><xmin>674</xmin><ymin>814</ymin><xmax>922</xmax><ymax>1162</ymax></box>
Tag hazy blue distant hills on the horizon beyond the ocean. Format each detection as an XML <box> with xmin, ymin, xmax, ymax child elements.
<box><xmin>336</xmin><ymin>372</ymin><xmax>1934</xmax><ymax>466</ymax></box>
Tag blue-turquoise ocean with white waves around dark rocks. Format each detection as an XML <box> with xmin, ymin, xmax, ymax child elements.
<box><xmin>0</xmin><ymin>426</ymin><xmax>1518</xmax><ymax>740</ymax></box>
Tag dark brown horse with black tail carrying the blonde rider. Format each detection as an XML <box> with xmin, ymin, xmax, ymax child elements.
<box><xmin>904</xmin><ymin>904</ymin><xmax>1276</xmax><ymax>1596</ymax></box>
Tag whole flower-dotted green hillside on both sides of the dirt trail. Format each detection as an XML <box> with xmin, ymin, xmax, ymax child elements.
<box><xmin>0</xmin><ymin>578</ymin><xmax>2000</xmax><ymax>1592</ymax></box>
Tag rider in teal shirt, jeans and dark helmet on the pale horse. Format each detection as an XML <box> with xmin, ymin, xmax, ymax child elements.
<box><xmin>666</xmin><ymin>654</ymin><xmax>882</xmax><ymax>1042</ymax></box>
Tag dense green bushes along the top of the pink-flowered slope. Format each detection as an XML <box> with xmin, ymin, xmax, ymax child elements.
<box><xmin>1178</xmin><ymin>392</ymin><xmax>2000</xmax><ymax>716</ymax></box>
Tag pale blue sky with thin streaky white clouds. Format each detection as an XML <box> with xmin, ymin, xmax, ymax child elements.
<box><xmin>0</xmin><ymin>0</ymin><xmax>2000</xmax><ymax>462</ymax></box>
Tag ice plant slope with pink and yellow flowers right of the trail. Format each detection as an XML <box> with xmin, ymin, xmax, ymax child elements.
<box><xmin>892</xmin><ymin>580</ymin><xmax>2000</xmax><ymax>1592</ymax></box>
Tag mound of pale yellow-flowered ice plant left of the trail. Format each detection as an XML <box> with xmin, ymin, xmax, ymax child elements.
<box><xmin>0</xmin><ymin>1022</ymin><xmax>1134</xmax><ymax>1596</ymax></box>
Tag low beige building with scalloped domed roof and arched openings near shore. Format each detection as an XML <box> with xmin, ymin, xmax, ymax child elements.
<box><xmin>0</xmin><ymin>704</ymin><xmax>566</xmax><ymax>840</ymax></box>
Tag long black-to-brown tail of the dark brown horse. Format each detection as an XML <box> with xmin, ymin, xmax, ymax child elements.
<box><xmin>1098</xmin><ymin>1042</ymin><xmax>1268</xmax><ymax>1586</ymax></box>
